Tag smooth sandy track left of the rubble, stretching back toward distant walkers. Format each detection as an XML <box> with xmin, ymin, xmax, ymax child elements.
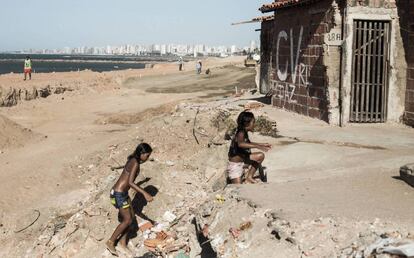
<box><xmin>0</xmin><ymin>60</ymin><xmax>253</xmax><ymax>232</ymax></box>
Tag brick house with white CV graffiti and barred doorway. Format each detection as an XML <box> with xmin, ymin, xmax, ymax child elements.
<box><xmin>260</xmin><ymin>0</ymin><xmax>414</xmax><ymax>125</ymax></box>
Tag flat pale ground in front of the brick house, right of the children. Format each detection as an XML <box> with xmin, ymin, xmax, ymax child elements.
<box><xmin>241</xmin><ymin>107</ymin><xmax>414</xmax><ymax>227</ymax></box>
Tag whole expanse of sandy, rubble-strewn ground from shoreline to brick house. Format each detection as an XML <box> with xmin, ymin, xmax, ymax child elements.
<box><xmin>0</xmin><ymin>57</ymin><xmax>414</xmax><ymax>257</ymax></box>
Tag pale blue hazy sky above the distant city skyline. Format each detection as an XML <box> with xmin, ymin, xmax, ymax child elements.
<box><xmin>0</xmin><ymin>0</ymin><xmax>272</xmax><ymax>50</ymax></box>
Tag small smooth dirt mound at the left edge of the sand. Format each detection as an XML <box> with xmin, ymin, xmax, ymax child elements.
<box><xmin>0</xmin><ymin>115</ymin><xmax>34</xmax><ymax>149</ymax></box>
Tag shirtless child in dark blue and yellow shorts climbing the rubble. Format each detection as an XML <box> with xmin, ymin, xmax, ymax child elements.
<box><xmin>106</xmin><ymin>143</ymin><xmax>153</xmax><ymax>256</ymax></box>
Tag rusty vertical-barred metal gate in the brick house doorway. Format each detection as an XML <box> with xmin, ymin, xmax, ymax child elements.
<box><xmin>350</xmin><ymin>20</ymin><xmax>390</xmax><ymax>123</ymax></box>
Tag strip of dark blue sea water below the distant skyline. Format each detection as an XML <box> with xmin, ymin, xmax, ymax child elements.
<box><xmin>0</xmin><ymin>54</ymin><xmax>176</xmax><ymax>74</ymax></box>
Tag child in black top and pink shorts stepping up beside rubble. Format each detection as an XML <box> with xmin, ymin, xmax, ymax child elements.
<box><xmin>227</xmin><ymin>111</ymin><xmax>272</xmax><ymax>184</ymax></box>
